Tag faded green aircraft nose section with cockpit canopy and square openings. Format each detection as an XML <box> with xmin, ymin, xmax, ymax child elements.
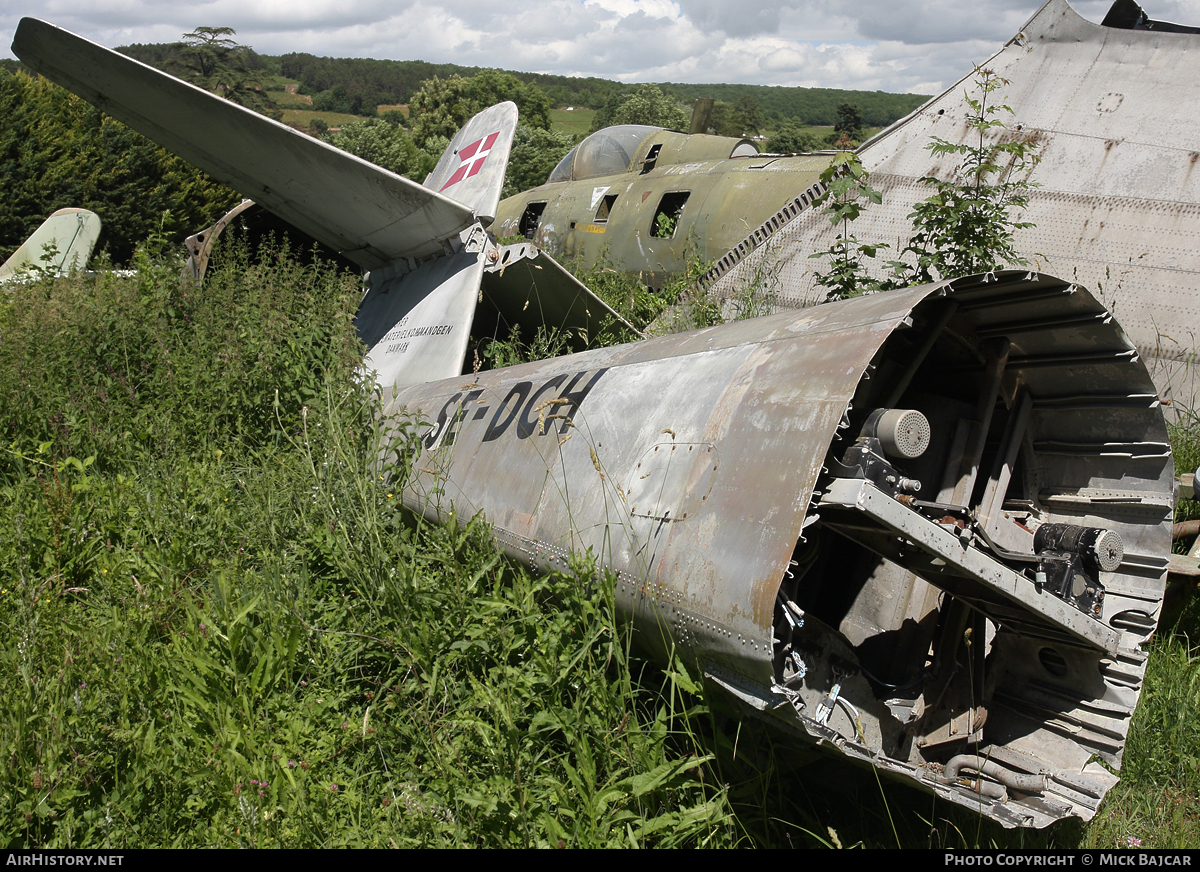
<box><xmin>492</xmin><ymin>125</ymin><xmax>833</xmax><ymax>287</ymax></box>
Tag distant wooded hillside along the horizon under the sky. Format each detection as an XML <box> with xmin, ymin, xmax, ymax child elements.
<box><xmin>110</xmin><ymin>44</ymin><xmax>929</xmax><ymax>127</ymax></box>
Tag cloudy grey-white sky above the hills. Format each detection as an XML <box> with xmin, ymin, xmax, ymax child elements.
<box><xmin>7</xmin><ymin>0</ymin><xmax>1200</xmax><ymax>94</ymax></box>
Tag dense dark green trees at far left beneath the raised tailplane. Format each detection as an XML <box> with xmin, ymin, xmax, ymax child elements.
<box><xmin>0</xmin><ymin>70</ymin><xmax>239</xmax><ymax>263</ymax></box>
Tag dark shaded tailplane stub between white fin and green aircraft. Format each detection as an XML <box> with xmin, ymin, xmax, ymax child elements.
<box><xmin>476</xmin><ymin>242</ymin><xmax>637</xmax><ymax>350</ymax></box>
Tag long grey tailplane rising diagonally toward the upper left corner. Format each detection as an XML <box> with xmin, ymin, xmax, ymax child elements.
<box><xmin>12</xmin><ymin>18</ymin><xmax>475</xmax><ymax>269</ymax></box>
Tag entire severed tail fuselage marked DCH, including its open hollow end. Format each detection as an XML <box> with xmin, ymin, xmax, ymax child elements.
<box><xmin>389</xmin><ymin>272</ymin><xmax>1174</xmax><ymax>825</ymax></box>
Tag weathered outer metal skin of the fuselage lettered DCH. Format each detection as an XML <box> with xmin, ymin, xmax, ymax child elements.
<box><xmin>392</xmin><ymin>281</ymin><xmax>928</xmax><ymax>685</ymax></box>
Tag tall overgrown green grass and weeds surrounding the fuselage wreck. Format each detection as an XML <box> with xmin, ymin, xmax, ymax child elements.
<box><xmin>0</xmin><ymin>245</ymin><xmax>1200</xmax><ymax>848</ymax></box>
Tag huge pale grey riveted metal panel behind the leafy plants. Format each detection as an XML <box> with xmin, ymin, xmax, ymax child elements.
<box><xmin>716</xmin><ymin>0</ymin><xmax>1200</xmax><ymax>408</ymax></box>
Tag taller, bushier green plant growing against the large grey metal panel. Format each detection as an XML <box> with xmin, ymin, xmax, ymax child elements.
<box><xmin>890</xmin><ymin>67</ymin><xmax>1040</xmax><ymax>284</ymax></box>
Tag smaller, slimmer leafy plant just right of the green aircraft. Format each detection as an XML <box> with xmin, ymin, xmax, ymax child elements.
<box><xmin>809</xmin><ymin>151</ymin><xmax>888</xmax><ymax>300</ymax></box>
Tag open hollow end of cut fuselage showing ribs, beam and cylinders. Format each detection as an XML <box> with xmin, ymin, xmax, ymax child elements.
<box><xmin>774</xmin><ymin>279</ymin><xmax>1174</xmax><ymax>825</ymax></box>
